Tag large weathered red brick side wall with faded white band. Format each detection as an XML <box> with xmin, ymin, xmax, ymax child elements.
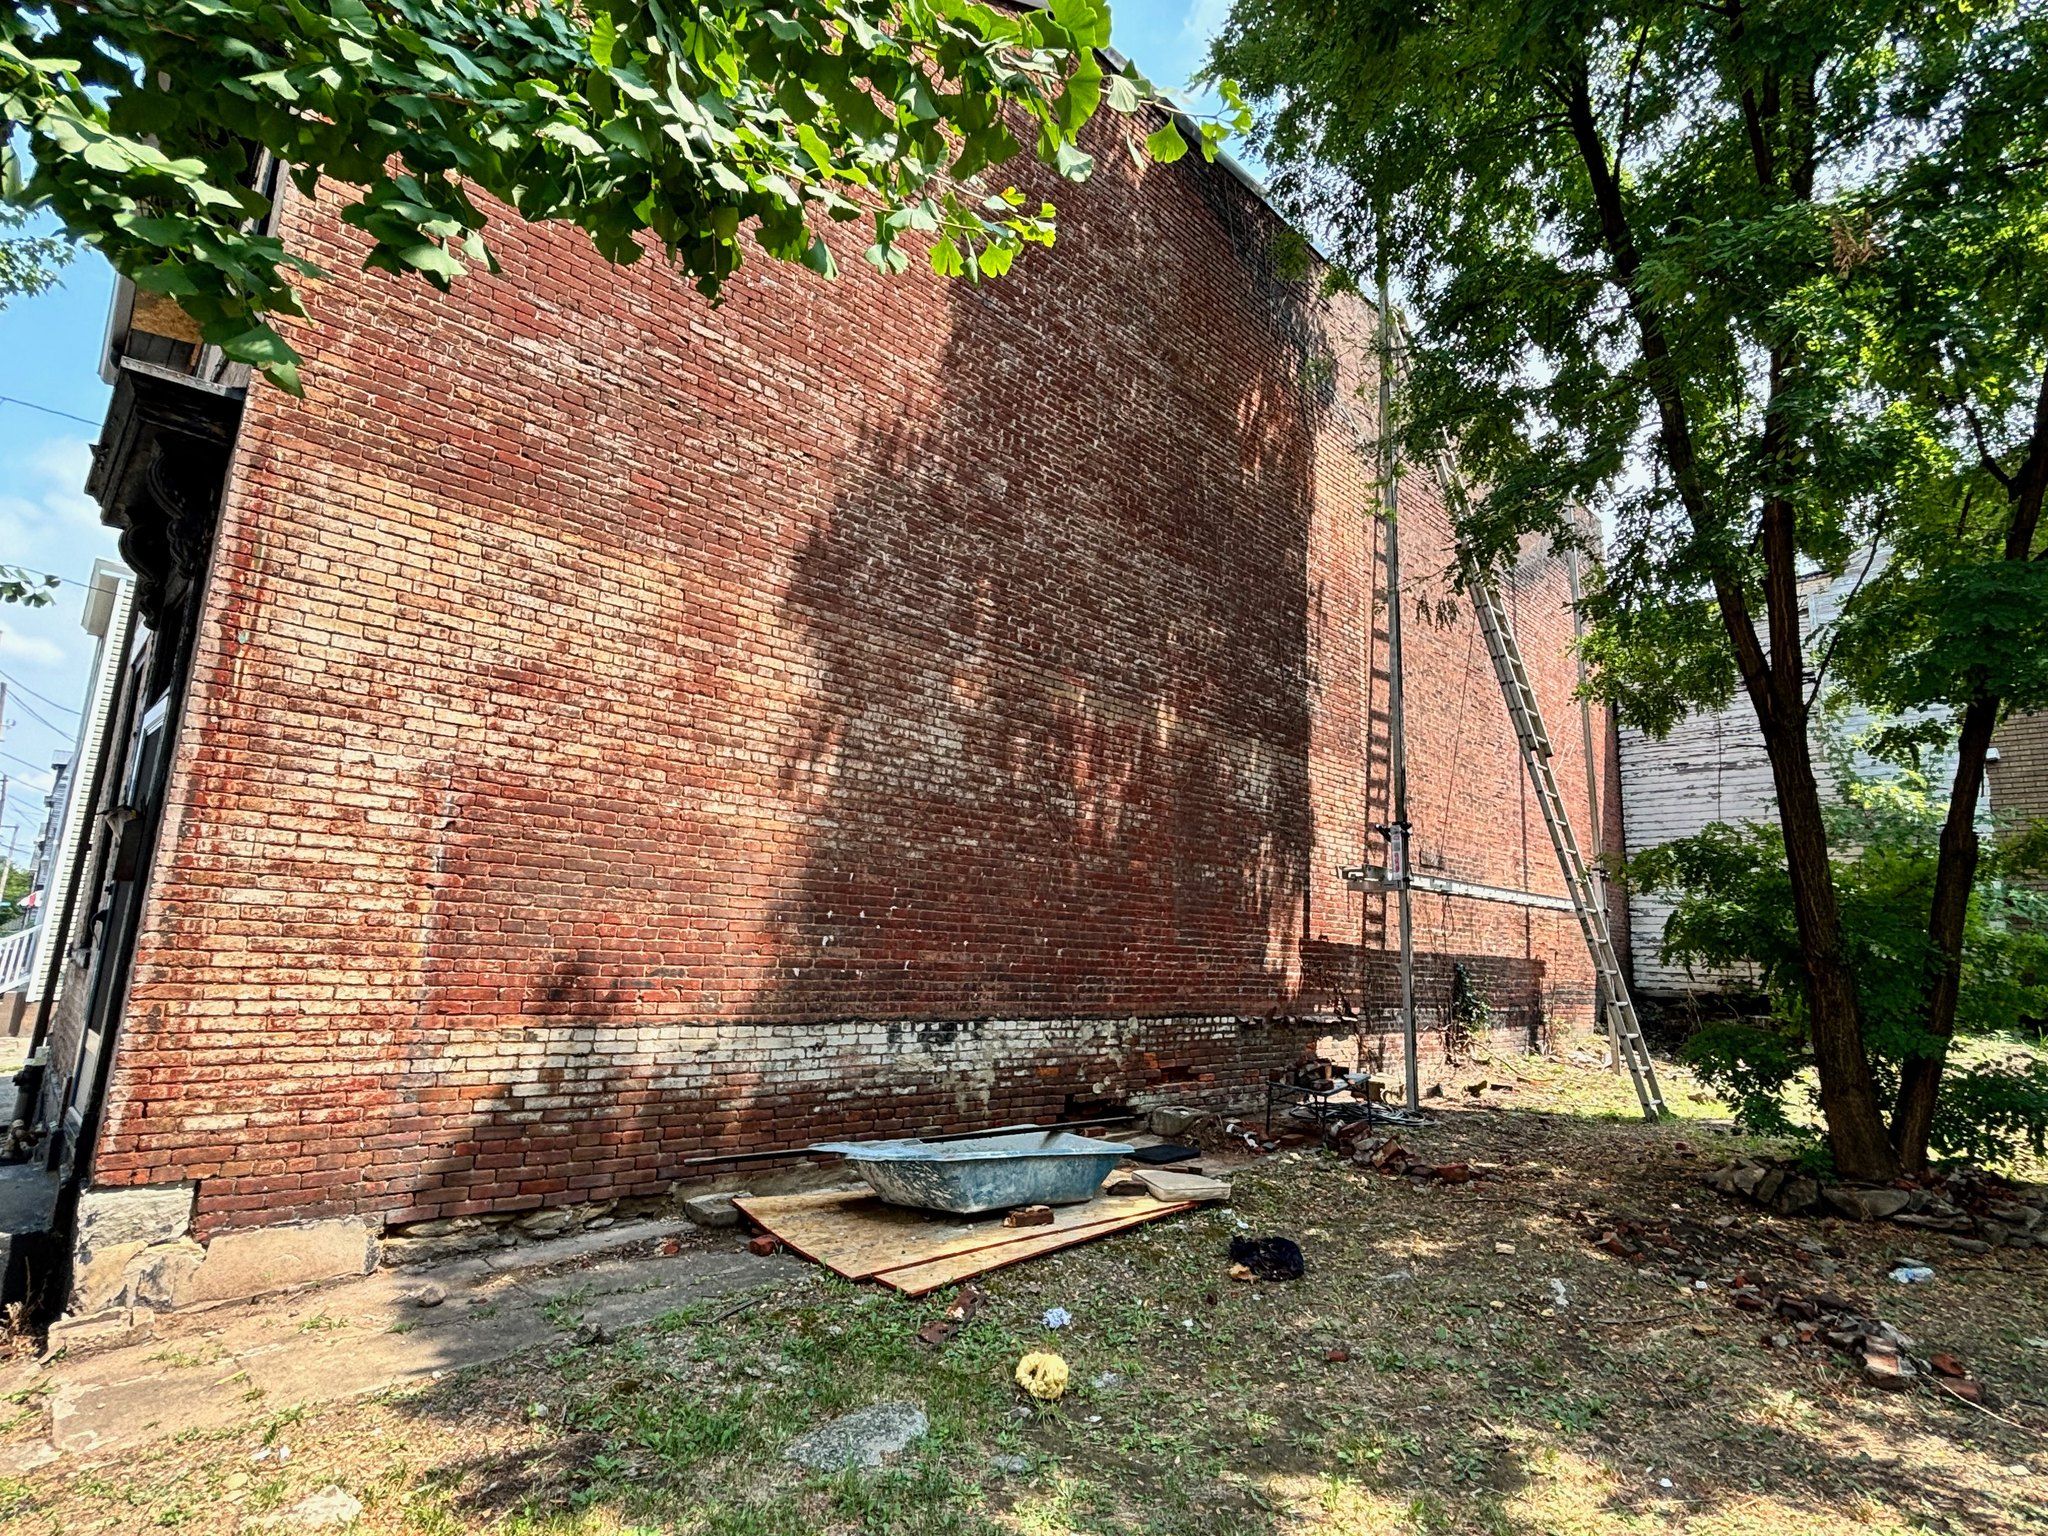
<box><xmin>94</xmin><ymin>114</ymin><xmax>1618</xmax><ymax>1231</ymax></box>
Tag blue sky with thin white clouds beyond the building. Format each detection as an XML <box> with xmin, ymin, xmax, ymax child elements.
<box><xmin>0</xmin><ymin>0</ymin><xmax>1229</xmax><ymax>858</ymax></box>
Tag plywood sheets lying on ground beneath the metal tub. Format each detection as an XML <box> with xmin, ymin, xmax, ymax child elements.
<box><xmin>733</xmin><ymin>1188</ymin><xmax>1192</xmax><ymax>1296</ymax></box>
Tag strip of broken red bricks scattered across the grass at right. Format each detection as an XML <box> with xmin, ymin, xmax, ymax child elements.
<box><xmin>1573</xmin><ymin>1210</ymin><xmax>1991</xmax><ymax>1407</ymax></box>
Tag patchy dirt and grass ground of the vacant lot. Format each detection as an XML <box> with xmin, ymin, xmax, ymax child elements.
<box><xmin>0</xmin><ymin>1057</ymin><xmax>2048</xmax><ymax>1536</ymax></box>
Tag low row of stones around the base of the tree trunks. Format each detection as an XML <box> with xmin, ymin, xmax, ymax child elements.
<box><xmin>1704</xmin><ymin>1159</ymin><xmax>2048</xmax><ymax>1253</ymax></box>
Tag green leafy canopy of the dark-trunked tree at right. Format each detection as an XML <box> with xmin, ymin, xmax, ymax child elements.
<box><xmin>1212</xmin><ymin>0</ymin><xmax>2048</xmax><ymax>729</ymax></box>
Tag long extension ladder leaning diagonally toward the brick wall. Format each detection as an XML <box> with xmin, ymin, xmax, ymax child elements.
<box><xmin>1436</xmin><ymin>446</ymin><xmax>1665</xmax><ymax>1120</ymax></box>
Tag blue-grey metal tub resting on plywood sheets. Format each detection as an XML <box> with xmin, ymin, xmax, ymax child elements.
<box><xmin>811</xmin><ymin>1130</ymin><xmax>1130</xmax><ymax>1217</ymax></box>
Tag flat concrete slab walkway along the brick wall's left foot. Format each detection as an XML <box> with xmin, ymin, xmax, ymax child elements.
<box><xmin>23</xmin><ymin>1223</ymin><xmax>815</xmax><ymax>1458</ymax></box>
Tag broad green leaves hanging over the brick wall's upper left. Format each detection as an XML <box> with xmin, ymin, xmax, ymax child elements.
<box><xmin>0</xmin><ymin>0</ymin><xmax>1217</xmax><ymax>389</ymax></box>
